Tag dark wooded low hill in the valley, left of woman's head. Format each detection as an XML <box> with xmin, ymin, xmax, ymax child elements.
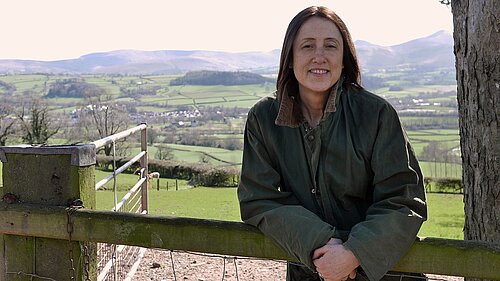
<box><xmin>170</xmin><ymin>70</ymin><xmax>276</xmax><ymax>86</ymax></box>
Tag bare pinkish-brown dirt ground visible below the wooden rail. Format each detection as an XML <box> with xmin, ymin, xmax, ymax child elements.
<box><xmin>133</xmin><ymin>249</ymin><xmax>464</xmax><ymax>281</ymax></box>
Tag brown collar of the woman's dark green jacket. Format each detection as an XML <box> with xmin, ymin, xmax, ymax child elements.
<box><xmin>274</xmin><ymin>76</ymin><xmax>344</xmax><ymax>128</ymax></box>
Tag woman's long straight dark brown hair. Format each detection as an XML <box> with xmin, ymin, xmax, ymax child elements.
<box><xmin>276</xmin><ymin>6</ymin><xmax>361</xmax><ymax>99</ymax></box>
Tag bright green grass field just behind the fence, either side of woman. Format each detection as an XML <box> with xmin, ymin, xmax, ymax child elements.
<box><xmin>97</xmin><ymin>186</ymin><xmax>464</xmax><ymax>239</ymax></box>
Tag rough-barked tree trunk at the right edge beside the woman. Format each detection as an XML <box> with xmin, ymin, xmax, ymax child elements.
<box><xmin>451</xmin><ymin>0</ymin><xmax>500</xmax><ymax>247</ymax></box>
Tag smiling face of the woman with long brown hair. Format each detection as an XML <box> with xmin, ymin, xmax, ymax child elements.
<box><xmin>293</xmin><ymin>17</ymin><xmax>344</xmax><ymax>96</ymax></box>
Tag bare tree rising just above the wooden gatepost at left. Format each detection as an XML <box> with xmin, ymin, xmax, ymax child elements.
<box><xmin>17</xmin><ymin>99</ymin><xmax>59</xmax><ymax>144</ymax></box>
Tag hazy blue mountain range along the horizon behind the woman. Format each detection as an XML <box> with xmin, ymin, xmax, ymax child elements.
<box><xmin>0</xmin><ymin>31</ymin><xmax>455</xmax><ymax>75</ymax></box>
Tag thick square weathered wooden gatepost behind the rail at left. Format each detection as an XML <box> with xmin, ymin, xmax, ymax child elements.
<box><xmin>0</xmin><ymin>145</ymin><xmax>97</xmax><ymax>281</ymax></box>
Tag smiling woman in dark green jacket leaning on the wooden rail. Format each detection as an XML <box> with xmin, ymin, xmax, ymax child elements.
<box><xmin>238</xmin><ymin>4</ymin><xmax>427</xmax><ymax>280</ymax></box>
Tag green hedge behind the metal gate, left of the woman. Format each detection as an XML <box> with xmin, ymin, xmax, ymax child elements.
<box><xmin>96</xmin><ymin>155</ymin><xmax>239</xmax><ymax>187</ymax></box>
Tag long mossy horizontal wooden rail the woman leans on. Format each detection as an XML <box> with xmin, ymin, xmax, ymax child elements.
<box><xmin>0</xmin><ymin>203</ymin><xmax>500</xmax><ymax>280</ymax></box>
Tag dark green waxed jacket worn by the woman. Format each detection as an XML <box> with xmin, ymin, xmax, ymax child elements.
<box><xmin>238</xmin><ymin>83</ymin><xmax>427</xmax><ymax>280</ymax></box>
